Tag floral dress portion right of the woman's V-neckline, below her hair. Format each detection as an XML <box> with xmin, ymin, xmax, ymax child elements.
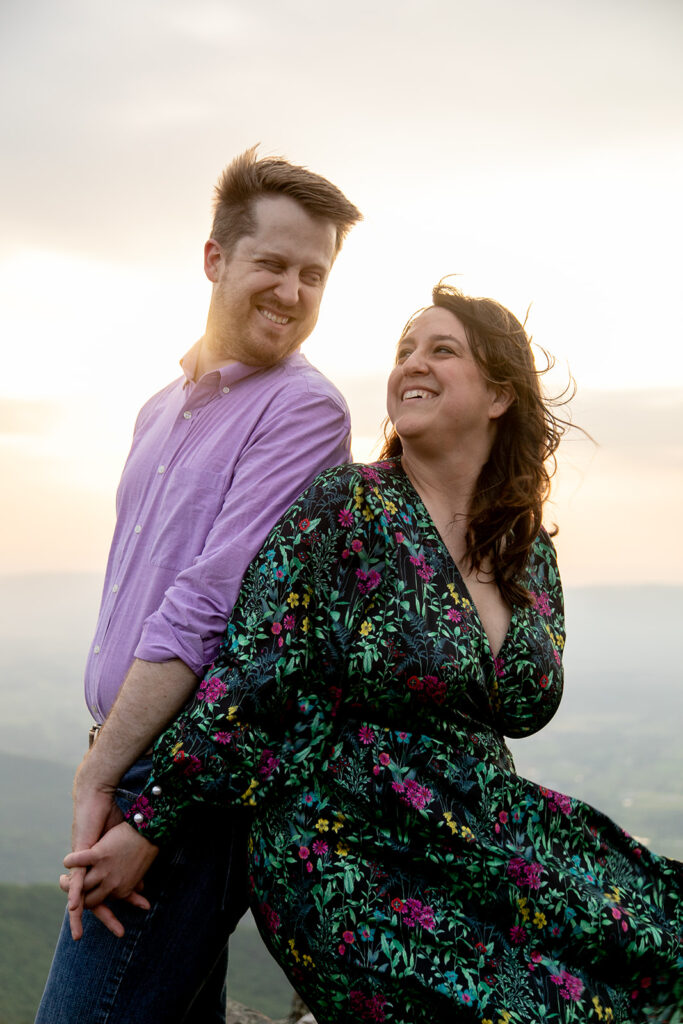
<box><xmin>490</xmin><ymin>529</ymin><xmax>565</xmax><ymax>738</ymax></box>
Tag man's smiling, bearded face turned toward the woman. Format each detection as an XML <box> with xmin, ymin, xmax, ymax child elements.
<box><xmin>204</xmin><ymin>196</ymin><xmax>337</xmax><ymax>367</ymax></box>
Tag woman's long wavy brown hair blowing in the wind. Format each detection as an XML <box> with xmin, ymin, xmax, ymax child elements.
<box><xmin>380</xmin><ymin>281</ymin><xmax>574</xmax><ymax>605</ymax></box>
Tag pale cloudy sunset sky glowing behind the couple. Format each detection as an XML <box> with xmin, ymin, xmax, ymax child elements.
<box><xmin>0</xmin><ymin>0</ymin><xmax>683</xmax><ymax>585</ymax></box>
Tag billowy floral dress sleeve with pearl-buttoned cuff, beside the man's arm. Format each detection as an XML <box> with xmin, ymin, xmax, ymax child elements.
<box><xmin>129</xmin><ymin>469</ymin><xmax>374</xmax><ymax>845</ymax></box>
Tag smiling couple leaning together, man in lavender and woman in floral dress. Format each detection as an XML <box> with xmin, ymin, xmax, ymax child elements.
<box><xmin>38</xmin><ymin>146</ymin><xmax>681</xmax><ymax>1024</ymax></box>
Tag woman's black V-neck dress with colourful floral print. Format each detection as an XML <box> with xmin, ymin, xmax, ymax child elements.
<box><xmin>131</xmin><ymin>461</ymin><xmax>683</xmax><ymax>1024</ymax></box>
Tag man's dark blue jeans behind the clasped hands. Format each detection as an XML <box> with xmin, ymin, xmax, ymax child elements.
<box><xmin>36</xmin><ymin>758</ymin><xmax>249</xmax><ymax>1024</ymax></box>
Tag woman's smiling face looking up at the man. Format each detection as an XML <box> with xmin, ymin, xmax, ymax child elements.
<box><xmin>387</xmin><ymin>306</ymin><xmax>509</xmax><ymax>452</ymax></box>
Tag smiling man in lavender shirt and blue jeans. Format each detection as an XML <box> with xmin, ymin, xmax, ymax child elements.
<box><xmin>37</xmin><ymin>147</ymin><xmax>360</xmax><ymax>1024</ymax></box>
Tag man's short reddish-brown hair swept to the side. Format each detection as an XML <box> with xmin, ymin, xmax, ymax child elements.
<box><xmin>211</xmin><ymin>145</ymin><xmax>362</xmax><ymax>256</ymax></box>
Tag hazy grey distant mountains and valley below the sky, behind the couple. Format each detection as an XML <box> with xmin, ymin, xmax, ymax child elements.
<box><xmin>0</xmin><ymin>574</ymin><xmax>683</xmax><ymax>882</ymax></box>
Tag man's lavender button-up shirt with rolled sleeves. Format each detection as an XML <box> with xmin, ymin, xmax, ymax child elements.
<box><xmin>85</xmin><ymin>345</ymin><xmax>350</xmax><ymax>722</ymax></box>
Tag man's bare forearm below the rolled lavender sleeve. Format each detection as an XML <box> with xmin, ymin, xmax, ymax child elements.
<box><xmin>79</xmin><ymin>658</ymin><xmax>198</xmax><ymax>786</ymax></box>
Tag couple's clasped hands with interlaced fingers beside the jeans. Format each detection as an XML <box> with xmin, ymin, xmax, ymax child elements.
<box><xmin>59</xmin><ymin>759</ymin><xmax>159</xmax><ymax>939</ymax></box>
